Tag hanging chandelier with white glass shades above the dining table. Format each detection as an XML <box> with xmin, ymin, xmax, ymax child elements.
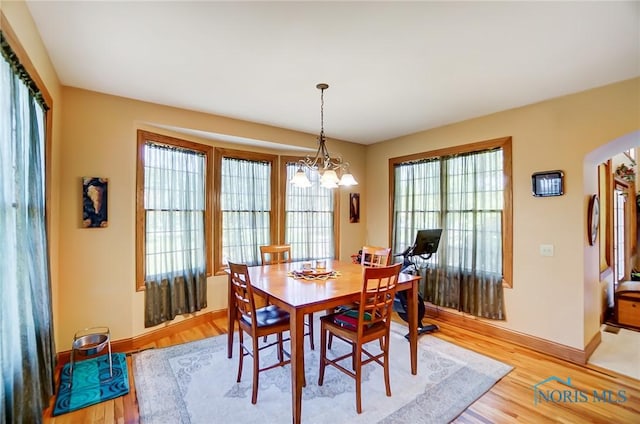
<box><xmin>290</xmin><ymin>83</ymin><xmax>358</xmax><ymax>188</ymax></box>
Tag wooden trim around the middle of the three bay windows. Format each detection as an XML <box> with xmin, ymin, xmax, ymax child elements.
<box><xmin>213</xmin><ymin>147</ymin><xmax>282</xmax><ymax>275</ymax></box>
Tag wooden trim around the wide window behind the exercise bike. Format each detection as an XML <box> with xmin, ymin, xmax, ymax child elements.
<box><xmin>388</xmin><ymin>137</ymin><xmax>513</xmax><ymax>288</ymax></box>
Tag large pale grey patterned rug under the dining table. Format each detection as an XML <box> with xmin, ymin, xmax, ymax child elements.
<box><xmin>133</xmin><ymin>323</ymin><xmax>512</xmax><ymax>424</ymax></box>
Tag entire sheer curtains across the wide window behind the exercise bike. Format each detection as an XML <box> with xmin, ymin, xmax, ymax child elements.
<box><xmin>393</xmin><ymin>150</ymin><xmax>505</xmax><ymax>320</ymax></box>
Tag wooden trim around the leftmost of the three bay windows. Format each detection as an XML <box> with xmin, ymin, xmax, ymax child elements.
<box><xmin>136</xmin><ymin>130</ymin><xmax>213</xmax><ymax>291</ymax></box>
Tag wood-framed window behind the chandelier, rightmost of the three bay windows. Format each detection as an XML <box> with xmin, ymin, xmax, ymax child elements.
<box><xmin>281</xmin><ymin>157</ymin><xmax>338</xmax><ymax>261</ymax></box>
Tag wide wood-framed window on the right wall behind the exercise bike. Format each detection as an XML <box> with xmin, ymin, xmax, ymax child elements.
<box><xmin>390</xmin><ymin>138</ymin><xmax>512</xmax><ymax>285</ymax></box>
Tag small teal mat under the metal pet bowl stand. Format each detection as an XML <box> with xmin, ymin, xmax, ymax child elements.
<box><xmin>53</xmin><ymin>353</ymin><xmax>129</xmax><ymax>416</ymax></box>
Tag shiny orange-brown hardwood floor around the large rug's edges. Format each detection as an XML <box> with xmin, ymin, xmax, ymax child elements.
<box><xmin>44</xmin><ymin>318</ymin><xmax>640</xmax><ymax>424</ymax></box>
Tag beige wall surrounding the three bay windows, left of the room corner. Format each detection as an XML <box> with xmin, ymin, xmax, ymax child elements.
<box><xmin>56</xmin><ymin>87</ymin><xmax>364</xmax><ymax>348</ymax></box>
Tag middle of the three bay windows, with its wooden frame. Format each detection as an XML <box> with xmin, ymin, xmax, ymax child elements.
<box><xmin>215</xmin><ymin>148</ymin><xmax>277</xmax><ymax>269</ymax></box>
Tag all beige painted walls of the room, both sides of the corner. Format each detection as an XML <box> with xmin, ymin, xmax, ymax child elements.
<box><xmin>6</xmin><ymin>1</ymin><xmax>640</xmax><ymax>350</ymax></box>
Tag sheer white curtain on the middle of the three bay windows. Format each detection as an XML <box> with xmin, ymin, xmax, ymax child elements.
<box><xmin>220</xmin><ymin>157</ymin><xmax>271</xmax><ymax>266</ymax></box>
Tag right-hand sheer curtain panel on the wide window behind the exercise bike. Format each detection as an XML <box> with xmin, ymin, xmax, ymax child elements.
<box><xmin>426</xmin><ymin>150</ymin><xmax>505</xmax><ymax>320</ymax></box>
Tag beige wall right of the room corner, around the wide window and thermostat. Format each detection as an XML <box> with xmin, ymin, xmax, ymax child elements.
<box><xmin>365</xmin><ymin>79</ymin><xmax>640</xmax><ymax>349</ymax></box>
